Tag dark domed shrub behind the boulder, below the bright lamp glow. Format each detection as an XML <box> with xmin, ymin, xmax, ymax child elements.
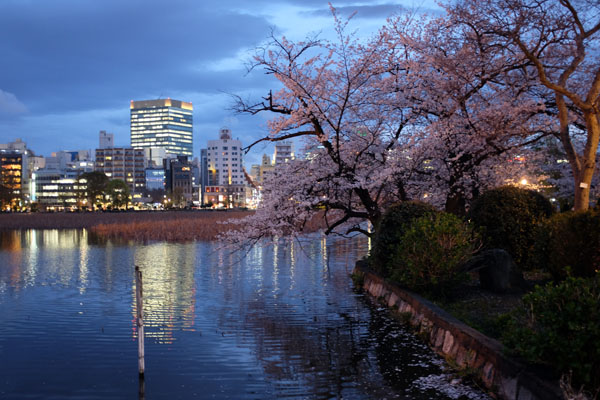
<box><xmin>469</xmin><ymin>186</ymin><xmax>553</xmax><ymax>269</ymax></box>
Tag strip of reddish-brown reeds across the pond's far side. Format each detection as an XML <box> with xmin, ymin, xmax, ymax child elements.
<box><xmin>0</xmin><ymin>211</ymin><xmax>252</xmax><ymax>241</ymax></box>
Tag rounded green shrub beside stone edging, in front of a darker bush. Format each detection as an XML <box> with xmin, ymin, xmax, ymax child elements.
<box><xmin>390</xmin><ymin>213</ymin><xmax>476</xmax><ymax>298</ymax></box>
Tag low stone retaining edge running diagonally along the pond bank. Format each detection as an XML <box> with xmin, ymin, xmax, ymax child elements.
<box><xmin>353</xmin><ymin>261</ymin><xmax>563</xmax><ymax>400</ymax></box>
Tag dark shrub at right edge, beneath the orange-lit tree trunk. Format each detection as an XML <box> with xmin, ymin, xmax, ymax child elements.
<box><xmin>535</xmin><ymin>210</ymin><xmax>600</xmax><ymax>280</ymax></box>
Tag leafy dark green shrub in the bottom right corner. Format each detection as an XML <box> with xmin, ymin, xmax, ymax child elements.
<box><xmin>503</xmin><ymin>275</ymin><xmax>600</xmax><ymax>390</ymax></box>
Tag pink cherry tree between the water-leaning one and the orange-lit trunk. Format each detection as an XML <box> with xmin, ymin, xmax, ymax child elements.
<box><xmin>383</xmin><ymin>11</ymin><xmax>552</xmax><ymax>214</ymax></box>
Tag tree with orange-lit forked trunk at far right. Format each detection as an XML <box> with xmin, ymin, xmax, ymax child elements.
<box><xmin>447</xmin><ymin>0</ymin><xmax>600</xmax><ymax>210</ymax></box>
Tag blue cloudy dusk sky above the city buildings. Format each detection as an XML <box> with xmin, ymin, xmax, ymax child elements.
<box><xmin>0</xmin><ymin>0</ymin><xmax>439</xmax><ymax>167</ymax></box>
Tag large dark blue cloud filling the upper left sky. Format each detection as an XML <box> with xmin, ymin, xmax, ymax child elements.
<box><xmin>0</xmin><ymin>0</ymin><xmax>269</xmax><ymax>112</ymax></box>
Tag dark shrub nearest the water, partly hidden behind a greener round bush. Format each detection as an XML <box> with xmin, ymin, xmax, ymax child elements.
<box><xmin>369</xmin><ymin>201</ymin><xmax>437</xmax><ymax>277</ymax></box>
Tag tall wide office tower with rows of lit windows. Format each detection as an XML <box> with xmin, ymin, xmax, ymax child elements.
<box><xmin>131</xmin><ymin>99</ymin><xmax>193</xmax><ymax>157</ymax></box>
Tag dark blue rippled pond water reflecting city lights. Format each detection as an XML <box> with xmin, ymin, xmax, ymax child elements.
<box><xmin>0</xmin><ymin>230</ymin><xmax>486</xmax><ymax>399</ymax></box>
